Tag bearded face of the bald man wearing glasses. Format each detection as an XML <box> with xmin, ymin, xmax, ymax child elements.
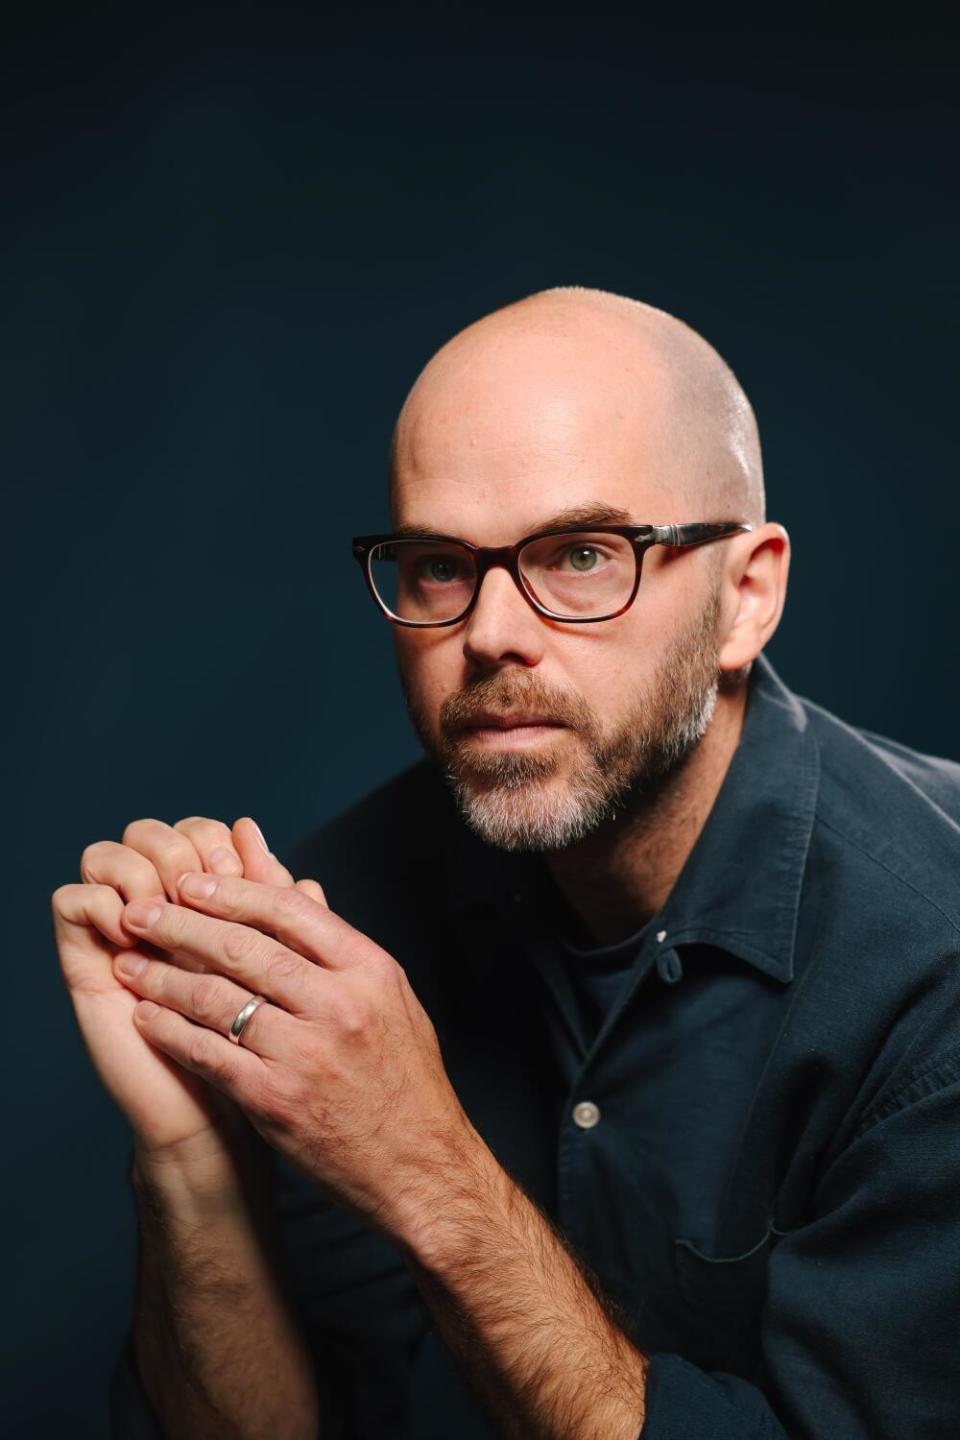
<box><xmin>394</xmin><ymin>321</ymin><xmax>720</xmax><ymax>851</ymax></box>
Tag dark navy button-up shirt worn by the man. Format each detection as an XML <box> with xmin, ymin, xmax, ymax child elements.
<box><xmin>114</xmin><ymin>657</ymin><xmax>960</xmax><ymax>1440</ymax></box>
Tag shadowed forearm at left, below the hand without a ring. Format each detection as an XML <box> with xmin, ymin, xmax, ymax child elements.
<box><xmin>132</xmin><ymin>1134</ymin><xmax>318</xmax><ymax>1440</ymax></box>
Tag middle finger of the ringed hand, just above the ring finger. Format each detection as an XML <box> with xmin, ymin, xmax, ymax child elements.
<box><xmin>124</xmin><ymin>898</ymin><xmax>322</xmax><ymax>1015</ymax></box>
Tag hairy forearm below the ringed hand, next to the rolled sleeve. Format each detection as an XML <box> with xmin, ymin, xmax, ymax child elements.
<box><xmin>394</xmin><ymin>1152</ymin><xmax>648</xmax><ymax>1440</ymax></box>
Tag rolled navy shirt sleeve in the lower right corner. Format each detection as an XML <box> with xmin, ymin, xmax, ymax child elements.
<box><xmin>640</xmin><ymin>1054</ymin><xmax>960</xmax><ymax>1440</ymax></box>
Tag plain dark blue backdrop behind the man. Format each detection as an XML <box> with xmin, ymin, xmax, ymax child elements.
<box><xmin>0</xmin><ymin>4</ymin><xmax>960</xmax><ymax>1437</ymax></box>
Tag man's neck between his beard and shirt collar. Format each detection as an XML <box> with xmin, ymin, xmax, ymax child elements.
<box><xmin>544</xmin><ymin>680</ymin><xmax>747</xmax><ymax>945</ymax></box>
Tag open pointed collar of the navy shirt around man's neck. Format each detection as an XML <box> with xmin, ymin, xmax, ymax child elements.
<box><xmin>448</xmin><ymin>654</ymin><xmax>819</xmax><ymax>984</ymax></box>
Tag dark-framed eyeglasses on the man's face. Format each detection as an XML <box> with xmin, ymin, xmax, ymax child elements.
<box><xmin>353</xmin><ymin>520</ymin><xmax>753</xmax><ymax>626</ymax></box>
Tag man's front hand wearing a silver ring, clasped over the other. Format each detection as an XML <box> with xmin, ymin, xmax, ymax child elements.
<box><xmin>114</xmin><ymin>874</ymin><xmax>479</xmax><ymax>1240</ymax></box>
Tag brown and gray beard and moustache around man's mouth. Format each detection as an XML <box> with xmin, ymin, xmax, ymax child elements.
<box><xmin>400</xmin><ymin>592</ymin><xmax>720</xmax><ymax>852</ymax></box>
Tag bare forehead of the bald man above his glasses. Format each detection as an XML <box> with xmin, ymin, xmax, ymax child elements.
<box><xmin>391</xmin><ymin>332</ymin><xmax>671</xmax><ymax>544</ymax></box>
